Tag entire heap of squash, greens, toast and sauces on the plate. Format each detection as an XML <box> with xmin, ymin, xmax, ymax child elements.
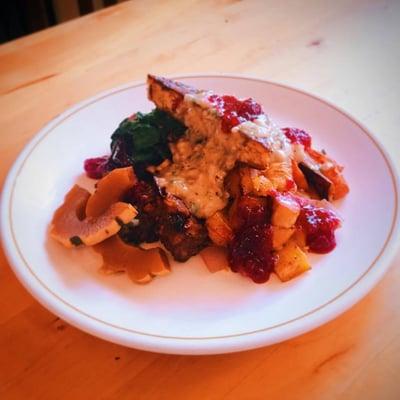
<box><xmin>50</xmin><ymin>75</ymin><xmax>349</xmax><ymax>283</ymax></box>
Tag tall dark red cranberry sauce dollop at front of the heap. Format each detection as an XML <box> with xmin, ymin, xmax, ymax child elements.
<box><xmin>228</xmin><ymin>196</ymin><xmax>276</xmax><ymax>283</ymax></box>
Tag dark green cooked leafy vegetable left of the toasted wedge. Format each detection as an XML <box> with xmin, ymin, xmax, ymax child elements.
<box><xmin>111</xmin><ymin>108</ymin><xmax>186</xmax><ymax>166</ymax></box>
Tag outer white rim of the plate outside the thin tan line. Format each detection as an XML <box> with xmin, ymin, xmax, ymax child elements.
<box><xmin>1</xmin><ymin>73</ymin><xmax>400</xmax><ymax>354</ymax></box>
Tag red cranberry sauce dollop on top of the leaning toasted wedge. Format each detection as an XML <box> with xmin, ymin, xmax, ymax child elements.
<box><xmin>207</xmin><ymin>94</ymin><xmax>263</xmax><ymax>133</ymax></box>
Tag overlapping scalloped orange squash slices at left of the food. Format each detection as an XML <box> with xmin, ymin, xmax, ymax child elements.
<box><xmin>50</xmin><ymin>167</ymin><xmax>169</xmax><ymax>283</ymax></box>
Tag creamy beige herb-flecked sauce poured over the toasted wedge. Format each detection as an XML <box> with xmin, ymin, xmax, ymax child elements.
<box><xmin>156</xmin><ymin>92</ymin><xmax>291</xmax><ymax>218</ymax></box>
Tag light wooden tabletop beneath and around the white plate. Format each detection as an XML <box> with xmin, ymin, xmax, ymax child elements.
<box><xmin>0</xmin><ymin>0</ymin><xmax>400</xmax><ymax>400</ymax></box>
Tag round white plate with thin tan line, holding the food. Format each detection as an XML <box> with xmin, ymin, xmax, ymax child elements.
<box><xmin>1</xmin><ymin>76</ymin><xmax>399</xmax><ymax>354</ymax></box>
